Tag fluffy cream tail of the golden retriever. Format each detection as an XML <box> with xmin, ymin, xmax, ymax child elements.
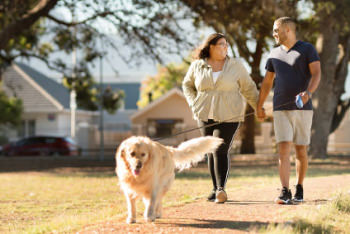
<box><xmin>173</xmin><ymin>136</ymin><xmax>223</xmax><ymax>170</ymax></box>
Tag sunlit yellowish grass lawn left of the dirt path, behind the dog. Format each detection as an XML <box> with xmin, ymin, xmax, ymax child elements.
<box><xmin>0</xmin><ymin>168</ymin><xmax>216</xmax><ymax>233</ymax></box>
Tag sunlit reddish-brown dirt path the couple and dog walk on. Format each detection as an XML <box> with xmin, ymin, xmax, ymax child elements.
<box><xmin>79</xmin><ymin>175</ymin><xmax>350</xmax><ymax>233</ymax></box>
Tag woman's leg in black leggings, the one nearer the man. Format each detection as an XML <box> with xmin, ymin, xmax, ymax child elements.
<box><xmin>213</xmin><ymin>122</ymin><xmax>239</xmax><ymax>189</ymax></box>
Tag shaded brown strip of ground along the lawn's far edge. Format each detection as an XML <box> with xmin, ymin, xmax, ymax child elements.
<box><xmin>0</xmin><ymin>157</ymin><xmax>350</xmax><ymax>180</ymax></box>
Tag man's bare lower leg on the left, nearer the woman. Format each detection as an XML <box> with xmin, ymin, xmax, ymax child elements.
<box><xmin>278</xmin><ymin>141</ymin><xmax>292</xmax><ymax>189</ymax></box>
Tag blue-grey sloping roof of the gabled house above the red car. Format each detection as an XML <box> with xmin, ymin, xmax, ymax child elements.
<box><xmin>16</xmin><ymin>63</ymin><xmax>70</xmax><ymax>109</ymax></box>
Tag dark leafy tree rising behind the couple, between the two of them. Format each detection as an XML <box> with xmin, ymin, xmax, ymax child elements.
<box><xmin>176</xmin><ymin>0</ymin><xmax>298</xmax><ymax>153</ymax></box>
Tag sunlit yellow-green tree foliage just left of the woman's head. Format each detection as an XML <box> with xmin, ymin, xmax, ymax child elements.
<box><xmin>137</xmin><ymin>59</ymin><xmax>190</xmax><ymax>107</ymax></box>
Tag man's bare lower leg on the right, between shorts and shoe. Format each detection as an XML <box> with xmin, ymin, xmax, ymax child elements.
<box><xmin>295</xmin><ymin>145</ymin><xmax>308</xmax><ymax>185</ymax></box>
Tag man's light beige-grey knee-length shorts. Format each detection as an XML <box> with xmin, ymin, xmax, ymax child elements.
<box><xmin>273</xmin><ymin>110</ymin><xmax>313</xmax><ymax>145</ymax></box>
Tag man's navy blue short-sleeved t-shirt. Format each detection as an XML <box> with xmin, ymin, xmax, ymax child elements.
<box><xmin>265</xmin><ymin>41</ymin><xmax>320</xmax><ymax>111</ymax></box>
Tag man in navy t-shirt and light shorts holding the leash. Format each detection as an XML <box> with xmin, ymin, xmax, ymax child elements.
<box><xmin>257</xmin><ymin>17</ymin><xmax>321</xmax><ymax>204</ymax></box>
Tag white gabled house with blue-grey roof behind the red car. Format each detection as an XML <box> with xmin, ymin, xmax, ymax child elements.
<box><xmin>3</xmin><ymin>63</ymin><xmax>98</xmax><ymax>147</ymax></box>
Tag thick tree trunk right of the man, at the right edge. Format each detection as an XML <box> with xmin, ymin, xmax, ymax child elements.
<box><xmin>310</xmin><ymin>0</ymin><xmax>350</xmax><ymax>158</ymax></box>
